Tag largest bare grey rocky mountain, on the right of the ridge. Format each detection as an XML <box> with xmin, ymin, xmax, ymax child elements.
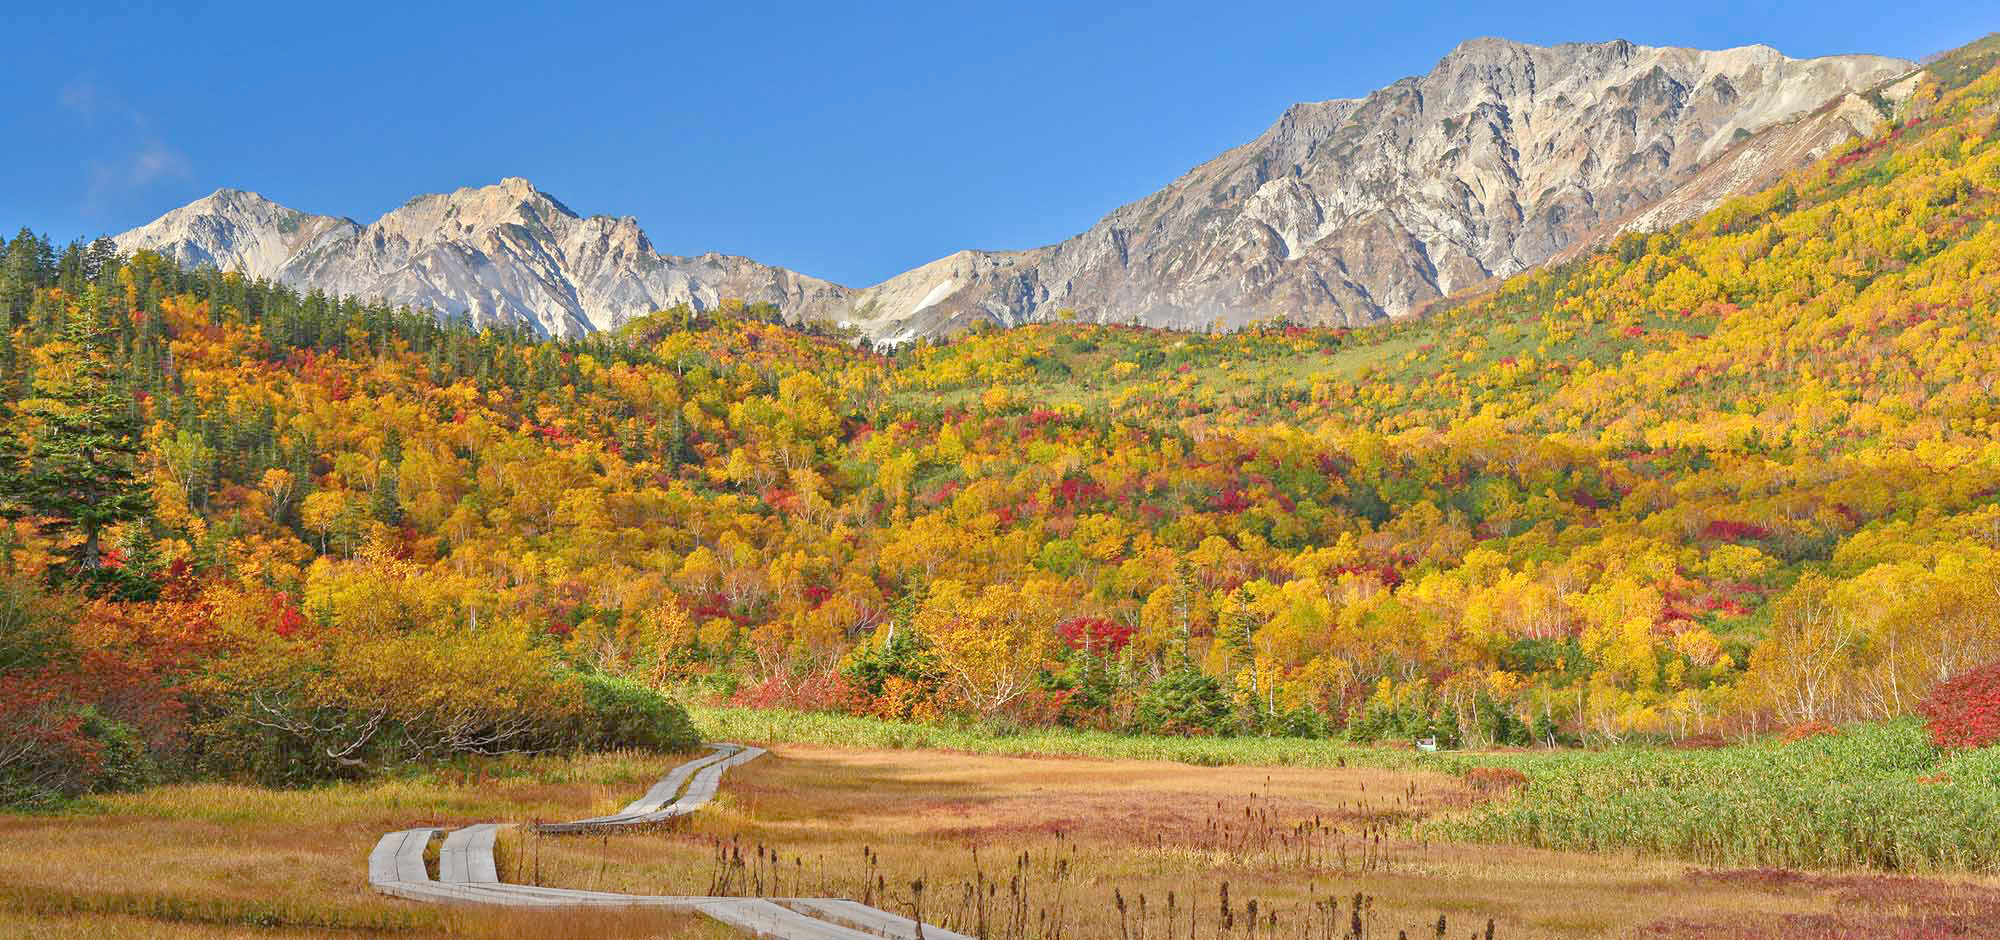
<box><xmin>864</xmin><ymin>40</ymin><xmax>1916</xmax><ymax>334</ymax></box>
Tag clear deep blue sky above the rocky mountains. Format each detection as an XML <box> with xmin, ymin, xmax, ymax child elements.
<box><xmin>0</xmin><ymin>0</ymin><xmax>2000</xmax><ymax>284</ymax></box>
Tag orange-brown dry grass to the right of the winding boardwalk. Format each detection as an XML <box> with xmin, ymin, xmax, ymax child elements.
<box><xmin>502</xmin><ymin>746</ymin><xmax>2000</xmax><ymax>940</ymax></box>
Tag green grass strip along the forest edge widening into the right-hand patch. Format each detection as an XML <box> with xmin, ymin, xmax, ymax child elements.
<box><xmin>692</xmin><ymin>706</ymin><xmax>2000</xmax><ymax>874</ymax></box>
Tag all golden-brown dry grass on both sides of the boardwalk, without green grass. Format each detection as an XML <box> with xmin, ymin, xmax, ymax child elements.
<box><xmin>0</xmin><ymin>746</ymin><xmax>2000</xmax><ymax>940</ymax></box>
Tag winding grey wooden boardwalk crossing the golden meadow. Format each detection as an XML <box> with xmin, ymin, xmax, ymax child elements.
<box><xmin>368</xmin><ymin>744</ymin><xmax>972</xmax><ymax>940</ymax></box>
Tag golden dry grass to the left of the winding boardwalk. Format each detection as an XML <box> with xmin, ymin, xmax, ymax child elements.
<box><xmin>0</xmin><ymin>754</ymin><xmax>734</xmax><ymax>938</ymax></box>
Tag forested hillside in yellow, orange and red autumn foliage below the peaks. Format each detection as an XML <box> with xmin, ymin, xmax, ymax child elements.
<box><xmin>0</xmin><ymin>33</ymin><xmax>2000</xmax><ymax>804</ymax></box>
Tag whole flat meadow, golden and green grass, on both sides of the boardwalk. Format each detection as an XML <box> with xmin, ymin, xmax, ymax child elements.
<box><xmin>0</xmin><ymin>728</ymin><xmax>2000</xmax><ymax>940</ymax></box>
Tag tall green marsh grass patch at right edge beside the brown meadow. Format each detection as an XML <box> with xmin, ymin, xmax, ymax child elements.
<box><xmin>1434</xmin><ymin>722</ymin><xmax>2000</xmax><ymax>874</ymax></box>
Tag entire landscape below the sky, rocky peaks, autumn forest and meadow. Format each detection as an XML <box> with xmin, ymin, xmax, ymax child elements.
<box><xmin>0</xmin><ymin>18</ymin><xmax>2000</xmax><ymax>940</ymax></box>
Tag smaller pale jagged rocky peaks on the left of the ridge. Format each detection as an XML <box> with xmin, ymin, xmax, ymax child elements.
<box><xmin>116</xmin><ymin>178</ymin><xmax>846</xmax><ymax>336</ymax></box>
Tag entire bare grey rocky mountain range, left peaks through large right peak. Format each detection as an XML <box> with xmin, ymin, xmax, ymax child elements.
<box><xmin>118</xmin><ymin>40</ymin><xmax>1916</xmax><ymax>342</ymax></box>
